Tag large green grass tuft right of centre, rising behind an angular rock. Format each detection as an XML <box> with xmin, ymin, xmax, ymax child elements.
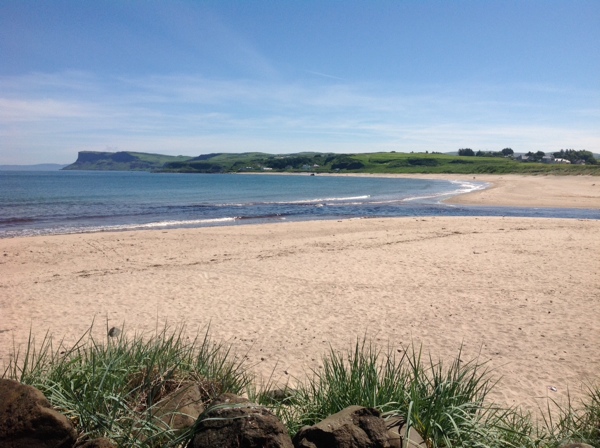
<box><xmin>263</xmin><ymin>339</ymin><xmax>540</xmax><ymax>448</ymax></box>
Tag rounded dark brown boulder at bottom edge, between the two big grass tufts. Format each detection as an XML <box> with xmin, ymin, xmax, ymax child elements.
<box><xmin>188</xmin><ymin>394</ymin><xmax>293</xmax><ymax>448</ymax></box>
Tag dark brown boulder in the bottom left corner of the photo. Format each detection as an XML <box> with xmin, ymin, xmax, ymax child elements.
<box><xmin>0</xmin><ymin>379</ymin><xmax>77</xmax><ymax>448</ymax></box>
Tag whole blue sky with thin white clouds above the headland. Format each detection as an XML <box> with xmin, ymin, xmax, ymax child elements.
<box><xmin>0</xmin><ymin>0</ymin><xmax>600</xmax><ymax>164</ymax></box>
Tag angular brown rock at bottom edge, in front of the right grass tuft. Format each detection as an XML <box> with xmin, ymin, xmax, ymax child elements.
<box><xmin>293</xmin><ymin>406</ymin><xmax>391</xmax><ymax>448</ymax></box>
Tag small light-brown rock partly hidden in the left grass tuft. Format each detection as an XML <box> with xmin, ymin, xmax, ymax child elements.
<box><xmin>152</xmin><ymin>381</ymin><xmax>204</xmax><ymax>430</ymax></box>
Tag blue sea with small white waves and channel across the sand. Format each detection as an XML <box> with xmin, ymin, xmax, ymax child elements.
<box><xmin>0</xmin><ymin>171</ymin><xmax>600</xmax><ymax>238</ymax></box>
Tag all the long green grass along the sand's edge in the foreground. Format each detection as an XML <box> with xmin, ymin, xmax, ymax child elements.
<box><xmin>3</xmin><ymin>328</ymin><xmax>600</xmax><ymax>448</ymax></box>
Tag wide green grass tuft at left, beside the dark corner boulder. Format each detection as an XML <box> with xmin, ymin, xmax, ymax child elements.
<box><xmin>4</xmin><ymin>327</ymin><xmax>252</xmax><ymax>447</ymax></box>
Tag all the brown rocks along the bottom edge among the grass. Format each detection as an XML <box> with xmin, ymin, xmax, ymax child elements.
<box><xmin>0</xmin><ymin>379</ymin><xmax>593</xmax><ymax>448</ymax></box>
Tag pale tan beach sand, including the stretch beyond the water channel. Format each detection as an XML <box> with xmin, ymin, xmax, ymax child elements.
<box><xmin>0</xmin><ymin>176</ymin><xmax>600</xmax><ymax>411</ymax></box>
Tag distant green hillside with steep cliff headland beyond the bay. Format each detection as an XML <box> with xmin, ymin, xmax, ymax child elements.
<box><xmin>65</xmin><ymin>151</ymin><xmax>600</xmax><ymax>175</ymax></box>
